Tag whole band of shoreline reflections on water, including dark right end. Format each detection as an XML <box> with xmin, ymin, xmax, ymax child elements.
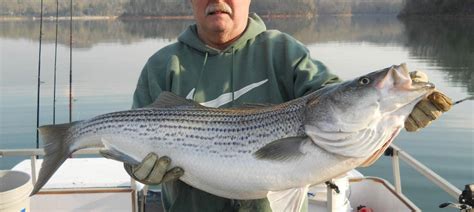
<box><xmin>0</xmin><ymin>16</ymin><xmax>474</xmax><ymax>91</ymax></box>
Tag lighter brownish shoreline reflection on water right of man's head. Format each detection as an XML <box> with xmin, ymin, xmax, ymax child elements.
<box><xmin>265</xmin><ymin>16</ymin><xmax>404</xmax><ymax>44</ymax></box>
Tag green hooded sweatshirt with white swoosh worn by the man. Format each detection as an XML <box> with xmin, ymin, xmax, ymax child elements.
<box><xmin>133</xmin><ymin>14</ymin><xmax>338</xmax><ymax>211</ymax></box>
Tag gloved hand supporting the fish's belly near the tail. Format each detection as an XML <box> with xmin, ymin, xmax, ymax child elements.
<box><xmin>124</xmin><ymin>153</ymin><xmax>184</xmax><ymax>185</ymax></box>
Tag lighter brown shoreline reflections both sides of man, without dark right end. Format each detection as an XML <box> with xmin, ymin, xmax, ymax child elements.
<box><xmin>0</xmin><ymin>16</ymin><xmax>403</xmax><ymax>48</ymax></box>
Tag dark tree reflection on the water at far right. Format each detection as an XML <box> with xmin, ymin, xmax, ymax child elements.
<box><xmin>403</xmin><ymin>19</ymin><xmax>474</xmax><ymax>95</ymax></box>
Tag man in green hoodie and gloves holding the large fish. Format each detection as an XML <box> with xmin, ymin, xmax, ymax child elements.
<box><xmin>121</xmin><ymin>0</ymin><xmax>447</xmax><ymax>211</ymax></box>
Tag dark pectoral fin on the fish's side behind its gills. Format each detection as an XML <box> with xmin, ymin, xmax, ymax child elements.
<box><xmin>254</xmin><ymin>136</ymin><xmax>309</xmax><ymax>161</ymax></box>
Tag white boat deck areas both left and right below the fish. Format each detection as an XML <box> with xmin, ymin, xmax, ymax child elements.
<box><xmin>12</xmin><ymin>158</ymin><xmax>420</xmax><ymax>212</ymax></box>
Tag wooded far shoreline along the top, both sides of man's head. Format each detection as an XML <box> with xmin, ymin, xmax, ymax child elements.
<box><xmin>0</xmin><ymin>0</ymin><xmax>474</xmax><ymax>16</ymax></box>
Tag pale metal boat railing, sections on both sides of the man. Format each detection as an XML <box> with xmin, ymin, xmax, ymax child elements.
<box><xmin>0</xmin><ymin>144</ymin><xmax>461</xmax><ymax>210</ymax></box>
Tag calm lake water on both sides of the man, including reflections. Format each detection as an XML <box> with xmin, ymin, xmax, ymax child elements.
<box><xmin>0</xmin><ymin>16</ymin><xmax>474</xmax><ymax>211</ymax></box>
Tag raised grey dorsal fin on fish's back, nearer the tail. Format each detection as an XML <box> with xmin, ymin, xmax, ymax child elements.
<box><xmin>147</xmin><ymin>91</ymin><xmax>204</xmax><ymax>108</ymax></box>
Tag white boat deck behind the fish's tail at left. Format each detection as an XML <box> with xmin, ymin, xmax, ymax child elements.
<box><xmin>12</xmin><ymin>158</ymin><xmax>143</xmax><ymax>212</ymax></box>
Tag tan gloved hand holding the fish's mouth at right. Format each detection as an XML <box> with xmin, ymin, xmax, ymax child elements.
<box><xmin>405</xmin><ymin>71</ymin><xmax>453</xmax><ymax>132</ymax></box>
